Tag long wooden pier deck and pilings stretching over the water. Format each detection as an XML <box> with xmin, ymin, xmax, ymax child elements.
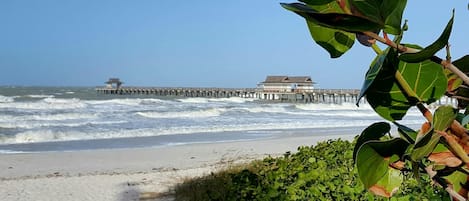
<box><xmin>96</xmin><ymin>87</ymin><xmax>360</xmax><ymax>104</ymax></box>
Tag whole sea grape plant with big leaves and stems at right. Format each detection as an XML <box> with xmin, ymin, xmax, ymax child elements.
<box><xmin>281</xmin><ymin>0</ymin><xmax>469</xmax><ymax>200</ymax></box>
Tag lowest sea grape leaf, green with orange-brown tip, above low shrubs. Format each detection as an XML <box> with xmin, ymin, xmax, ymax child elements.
<box><xmin>356</xmin><ymin>138</ymin><xmax>408</xmax><ymax>197</ymax></box>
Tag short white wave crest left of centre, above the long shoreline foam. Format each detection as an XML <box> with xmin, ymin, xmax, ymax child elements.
<box><xmin>136</xmin><ymin>108</ymin><xmax>224</xmax><ymax>119</ymax></box>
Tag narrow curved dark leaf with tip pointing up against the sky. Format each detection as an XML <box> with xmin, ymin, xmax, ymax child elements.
<box><xmin>399</xmin><ymin>10</ymin><xmax>454</xmax><ymax>63</ymax></box>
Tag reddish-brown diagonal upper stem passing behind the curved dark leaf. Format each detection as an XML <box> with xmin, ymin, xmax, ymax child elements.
<box><xmin>363</xmin><ymin>31</ymin><xmax>469</xmax><ymax>85</ymax></box>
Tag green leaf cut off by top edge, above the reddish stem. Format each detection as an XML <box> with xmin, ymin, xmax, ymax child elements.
<box><xmin>350</xmin><ymin>0</ymin><xmax>407</xmax><ymax>35</ymax></box>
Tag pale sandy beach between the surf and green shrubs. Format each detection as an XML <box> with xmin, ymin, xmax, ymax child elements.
<box><xmin>0</xmin><ymin>136</ymin><xmax>353</xmax><ymax>201</ymax></box>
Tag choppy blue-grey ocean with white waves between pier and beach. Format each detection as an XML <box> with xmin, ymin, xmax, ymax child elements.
<box><xmin>0</xmin><ymin>87</ymin><xmax>423</xmax><ymax>154</ymax></box>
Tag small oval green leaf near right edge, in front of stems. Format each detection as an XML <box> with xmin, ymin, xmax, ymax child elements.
<box><xmin>433</xmin><ymin>105</ymin><xmax>458</xmax><ymax>131</ymax></box>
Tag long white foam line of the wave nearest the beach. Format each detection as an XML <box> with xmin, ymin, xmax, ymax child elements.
<box><xmin>0</xmin><ymin>121</ymin><xmax>378</xmax><ymax>144</ymax></box>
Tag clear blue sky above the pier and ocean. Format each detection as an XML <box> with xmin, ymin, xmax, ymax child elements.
<box><xmin>0</xmin><ymin>0</ymin><xmax>469</xmax><ymax>89</ymax></box>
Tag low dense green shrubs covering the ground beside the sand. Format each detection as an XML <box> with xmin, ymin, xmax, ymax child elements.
<box><xmin>175</xmin><ymin>139</ymin><xmax>449</xmax><ymax>201</ymax></box>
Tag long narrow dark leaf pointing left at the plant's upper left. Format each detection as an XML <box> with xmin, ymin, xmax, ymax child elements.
<box><xmin>281</xmin><ymin>3</ymin><xmax>384</xmax><ymax>33</ymax></box>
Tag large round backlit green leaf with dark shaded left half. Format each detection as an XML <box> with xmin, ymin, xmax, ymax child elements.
<box><xmin>366</xmin><ymin>51</ymin><xmax>447</xmax><ymax>121</ymax></box>
